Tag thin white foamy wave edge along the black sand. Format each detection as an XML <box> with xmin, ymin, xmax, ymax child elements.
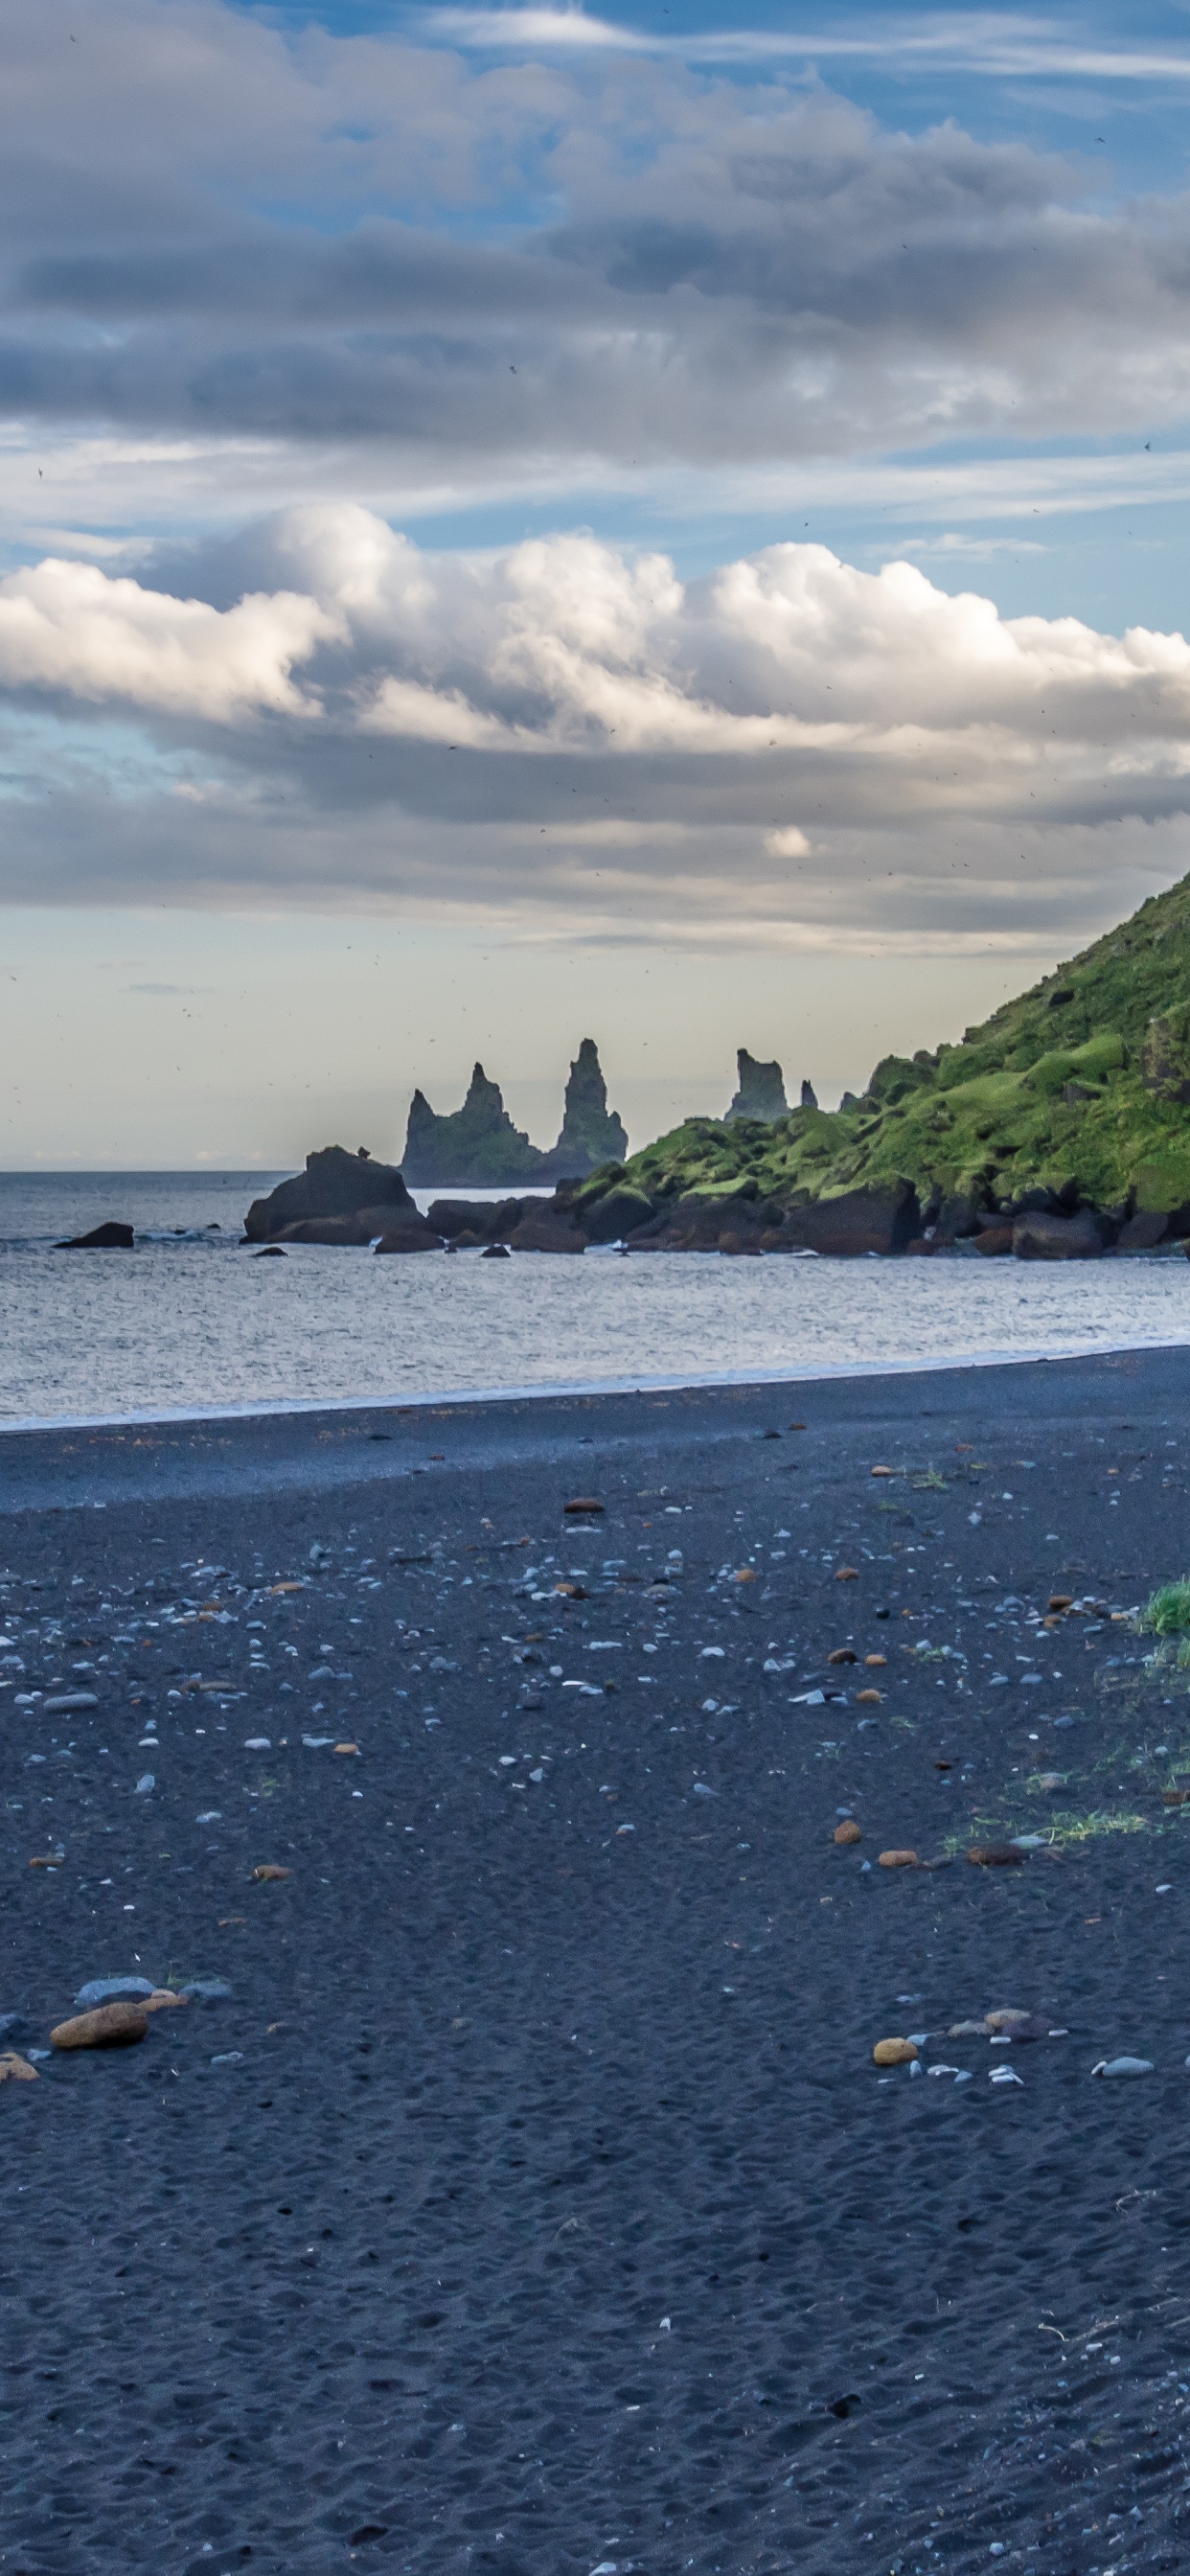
<box><xmin>0</xmin><ymin>1337</ymin><xmax>1190</xmax><ymax>1440</ymax></box>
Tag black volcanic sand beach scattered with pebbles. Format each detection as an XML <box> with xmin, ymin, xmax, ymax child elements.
<box><xmin>0</xmin><ymin>1352</ymin><xmax>1190</xmax><ymax>2576</ymax></box>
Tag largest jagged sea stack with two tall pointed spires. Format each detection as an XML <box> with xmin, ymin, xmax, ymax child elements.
<box><xmin>401</xmin><ymin>1038</ymin><xmax>629</xmax><ymax>1190</ymax></box>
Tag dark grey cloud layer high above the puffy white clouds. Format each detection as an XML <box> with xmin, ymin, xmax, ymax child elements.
<box><xmin>0</xmin><ymin>0</ymin><xmax>1190</xmax><ymax>479</ymax></box>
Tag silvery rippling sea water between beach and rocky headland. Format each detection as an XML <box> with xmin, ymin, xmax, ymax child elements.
<box><xmin>0</xmin><ymin>1172</ymin><xmax>1190</xmax><ymax>1424</ymax></box>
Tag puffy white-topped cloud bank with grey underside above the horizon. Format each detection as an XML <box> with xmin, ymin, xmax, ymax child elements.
<box><xmin>0</xmin><ymin>505</ymin><xmax>1190</xmax><ymax>948</ymax></box>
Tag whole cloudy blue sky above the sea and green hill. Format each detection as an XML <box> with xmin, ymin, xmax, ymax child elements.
<box><xmin>0</xmin><ymin>0</ymin><xmax>1190</xmax><ymax>1169</ymax></box>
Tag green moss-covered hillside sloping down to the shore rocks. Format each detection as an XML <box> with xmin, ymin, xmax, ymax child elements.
<box><xmin>566</xmin><ymin>879</ymin><xmax>1190</xmax><ymax>1210</ymax></box>
